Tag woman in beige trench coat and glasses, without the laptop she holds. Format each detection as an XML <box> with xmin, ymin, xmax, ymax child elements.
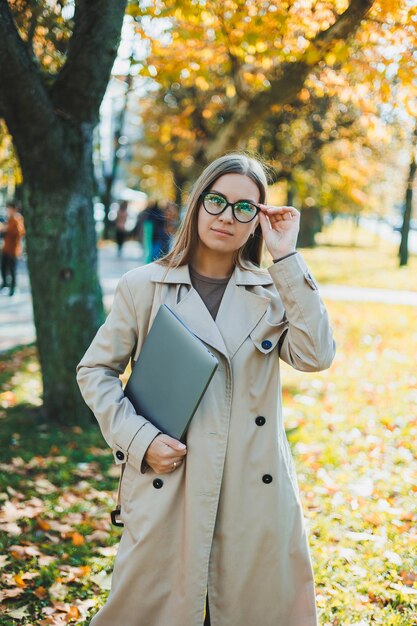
<box><xmin>78</xmin><ymin>154</ymin><xmax>334</xmax><ymax>626</ymax></box>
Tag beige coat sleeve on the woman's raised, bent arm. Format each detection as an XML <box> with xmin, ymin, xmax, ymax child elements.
<box><xmin>268</xmin><ymin>253</ymin><xmax>336</xmax><ymax>372</ymax></box>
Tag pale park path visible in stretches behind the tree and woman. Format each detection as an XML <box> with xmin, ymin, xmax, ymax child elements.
<box><xmin>0</xmin><ymin>241</ymin><xmax>417</xmax><ymax>352</ymax></box>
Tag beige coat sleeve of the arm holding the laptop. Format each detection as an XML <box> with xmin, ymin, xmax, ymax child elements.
<box><xmin>77</xmin><ymin>276</ymin><xmax>160</xmax><ymax>471</ymax></box>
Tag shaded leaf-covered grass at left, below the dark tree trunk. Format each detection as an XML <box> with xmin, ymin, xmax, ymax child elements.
<box><xmin>0</xmin><ymin>347</ymin><xmax>120</xmax><ymax>626</ymax></box>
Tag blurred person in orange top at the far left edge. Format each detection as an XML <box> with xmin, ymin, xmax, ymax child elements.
<box><xmin>0</xmin><ymin>200</ymin><xmax>25</xmax><ymax>296</ymax></box>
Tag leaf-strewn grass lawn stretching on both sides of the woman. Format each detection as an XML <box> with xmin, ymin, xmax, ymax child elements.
<box><xmin>0</xmin><ymin>233</ymin><xmax>417</xmax><ymax>626</ymax></box>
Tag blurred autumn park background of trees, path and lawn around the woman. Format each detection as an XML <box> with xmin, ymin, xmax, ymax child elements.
<box><xmin>0</xmin><ymin>0</ymin><xmax>417</xmax><ymax>626</ymax></box>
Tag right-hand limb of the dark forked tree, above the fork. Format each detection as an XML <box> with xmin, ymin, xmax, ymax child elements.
<box><xmin>51</xmin><ymin>0</ymin><xmax>126</xmax><ymax>123</ymax></box>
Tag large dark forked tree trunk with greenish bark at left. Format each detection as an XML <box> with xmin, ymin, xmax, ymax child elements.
<box><xmin>0</xmin><ymin>0</ymin><xmax>126</xmax><ymax>424</ymax></box>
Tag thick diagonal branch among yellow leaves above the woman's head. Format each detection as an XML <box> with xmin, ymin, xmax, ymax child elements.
<box><xmin>204</xmin><ymin>0</ymin><xmax>375</xmax><ymax>161</ymax></box>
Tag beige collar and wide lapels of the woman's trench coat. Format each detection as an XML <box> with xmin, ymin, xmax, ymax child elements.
<box><xmin>152</xmin><ymin>265</ymin><xmax>273</xmax><ymax>359</ymax></box>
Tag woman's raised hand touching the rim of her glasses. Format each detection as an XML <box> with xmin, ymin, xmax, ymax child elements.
<box><xmin>259</xmin><ymin>204</ymin><xmax>300</xmax><ymax>259</ymax></box>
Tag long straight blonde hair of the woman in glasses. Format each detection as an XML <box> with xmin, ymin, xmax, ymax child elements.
<box><xmin>157</xmin><ymin>153</ymin><xmax>268</xmax><ymax>271</ymax></box>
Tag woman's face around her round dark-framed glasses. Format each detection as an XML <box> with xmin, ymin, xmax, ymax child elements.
<box><xmin>198</xmin><ymin>174</ymin><xmax>260</xmax><ymax>254</ymax></box>
